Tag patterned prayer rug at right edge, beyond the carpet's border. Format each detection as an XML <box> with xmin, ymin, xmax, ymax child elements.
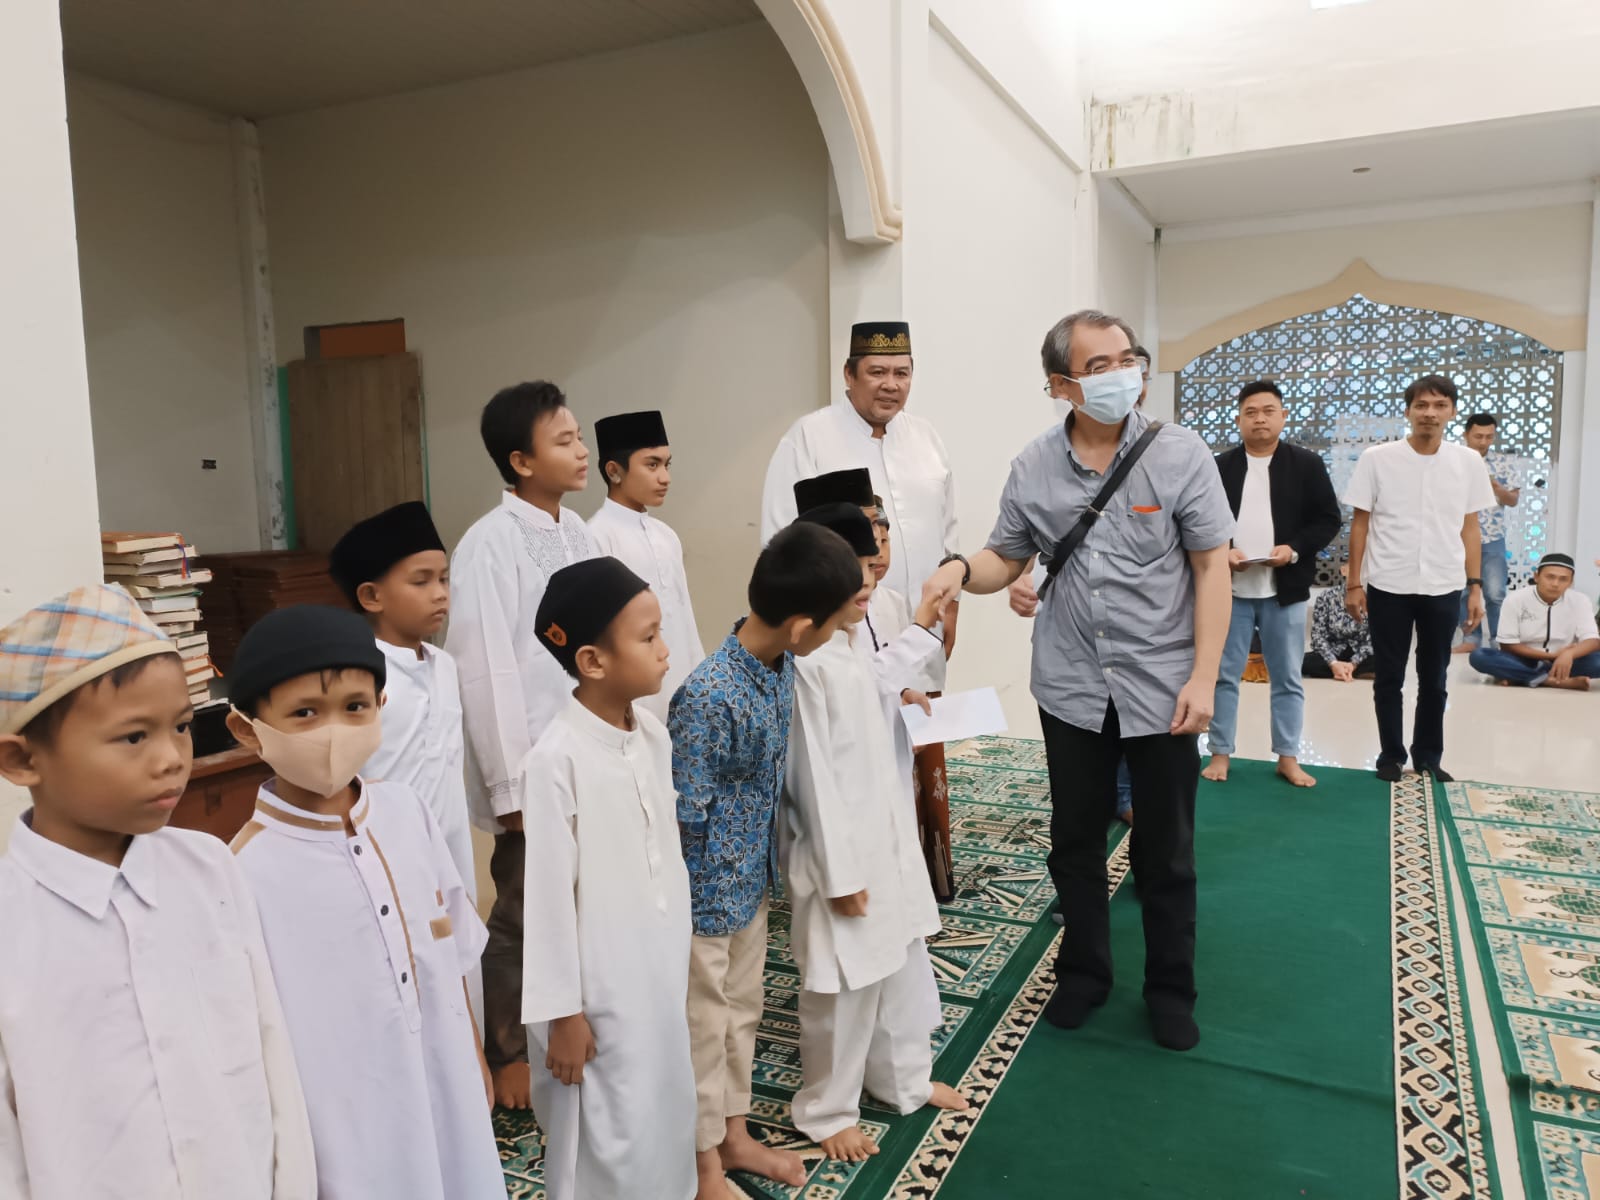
<box><xmin>1440</xmin><ymin>784</ymin><xmax>1600</xmax><ymax>1200</ymax></box>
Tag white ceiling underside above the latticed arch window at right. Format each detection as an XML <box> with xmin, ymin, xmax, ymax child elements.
<box><xmin>1109</xmin><ymin>109</ymin><xmax>1600</xmax><ymax>229</ymax></box>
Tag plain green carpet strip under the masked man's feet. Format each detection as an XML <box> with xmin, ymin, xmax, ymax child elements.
<box><xmin>939</xmin><ymin>762</ymin><xmax>1433</xmax><ymax>1200</ymax></box>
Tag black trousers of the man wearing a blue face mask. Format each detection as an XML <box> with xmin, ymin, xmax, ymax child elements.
<box><xmin>1038</xmin><ymin>704</ymin><xmax>1200</xmax><ymax>1013</ymax></box>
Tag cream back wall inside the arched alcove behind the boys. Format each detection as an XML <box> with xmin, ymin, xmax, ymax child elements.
<box><xmin>261</xmin><ymin>26</ymin><xmax>829</xmax><ymax>645</ymax></box>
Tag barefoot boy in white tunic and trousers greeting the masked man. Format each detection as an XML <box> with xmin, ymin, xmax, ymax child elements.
<box><xmin>782</xmin><ymin>502</ymin><xmax>966</xmax><ymax>1162</ymax></box>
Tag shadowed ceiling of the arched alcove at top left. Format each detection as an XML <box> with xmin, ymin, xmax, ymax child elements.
<box><xmin>61</xmin><ymin>0</ymin><xmax>760</xmax><ymax>118</ymax></box>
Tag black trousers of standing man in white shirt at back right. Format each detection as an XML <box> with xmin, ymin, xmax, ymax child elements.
<box><xmin>1366</xmin><ymin>587</ymin><xmax>1461</xmax><ymax>771</ymax></box>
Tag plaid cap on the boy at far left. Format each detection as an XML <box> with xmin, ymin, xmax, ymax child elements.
<box><xmin>0</xmin><ymin>584</ymin><xmax>178</xmax><ymax>734</ymax></box>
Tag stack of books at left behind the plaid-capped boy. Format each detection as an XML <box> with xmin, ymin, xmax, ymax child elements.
<box><xmin>101</xmin><ymin>533</ymin><xmax>216</xmax><ymax>704</ymax></box>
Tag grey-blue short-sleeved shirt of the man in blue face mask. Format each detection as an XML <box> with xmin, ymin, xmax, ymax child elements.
<box><xmin>989</xmin><ymin>413</ymin><xmax>1234</xmax><ymax>738</ymax></box>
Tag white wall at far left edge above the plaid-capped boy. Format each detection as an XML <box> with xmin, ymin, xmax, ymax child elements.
<box><xmin>0</xmin><ymin>0</ymin><xmax>99</xmax><ymax>850</ymax></box>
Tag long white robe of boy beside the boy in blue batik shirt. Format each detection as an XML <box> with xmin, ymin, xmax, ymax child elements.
<box><xmin>520</xmin><ymin>698</ymin><xmax>696</xmax><ymax>1200</ymax></box>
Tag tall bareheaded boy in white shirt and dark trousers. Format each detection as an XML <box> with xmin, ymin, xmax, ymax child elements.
<box><xmin>445</xmin><ymin>381</ymin><xmax>594</xmax><ymax>1109</ymax></box>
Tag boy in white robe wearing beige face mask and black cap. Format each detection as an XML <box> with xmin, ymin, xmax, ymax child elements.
<box><xmin>227</xmin><ymin>605</ymin><xmax>506</xmax><ymax>1200</ymax></box>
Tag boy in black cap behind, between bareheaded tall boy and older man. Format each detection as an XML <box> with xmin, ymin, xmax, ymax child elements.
<box><xmin>589</xmin><ymin>413</ymin><xmax>706</xmax><ymax>723</ymax></box>
